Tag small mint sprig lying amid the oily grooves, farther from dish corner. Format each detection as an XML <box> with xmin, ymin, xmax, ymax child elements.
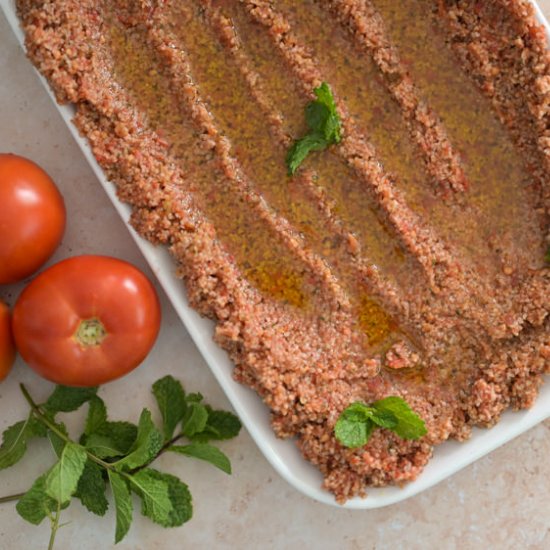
<box><xmin>286</xmin><ymin>82</ymin><xmax>342</xmax><ymax>176</ymax></box>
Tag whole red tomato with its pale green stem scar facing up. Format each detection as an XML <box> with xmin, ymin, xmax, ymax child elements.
<box><xmin>12</xmin><ymin>256</ymin><xmax>160</xmax><ymax>386</ymax></box>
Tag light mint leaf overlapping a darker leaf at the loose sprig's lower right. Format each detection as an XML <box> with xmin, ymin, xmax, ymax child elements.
<box><xmin>129</xmin><ymin>468</ymin><xmax>174</xmax><ymax>527</ymax></box>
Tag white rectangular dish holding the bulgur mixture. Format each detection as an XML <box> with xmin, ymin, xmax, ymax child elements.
<box><xmin>0</xmin><ymin>0</ymin><xmax>550</xmax><ymax>509</ymax></box>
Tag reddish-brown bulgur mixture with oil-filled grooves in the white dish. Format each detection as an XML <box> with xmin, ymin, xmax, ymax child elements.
<box><xmin>17</xmin><ymin>0</ymin><xmax>550</xmax><ymax>502</ymax></box>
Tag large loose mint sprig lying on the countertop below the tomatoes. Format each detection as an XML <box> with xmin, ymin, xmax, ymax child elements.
<box><xmin>0</xmin><ymin>376</ymin><xmax>241</xmax><ymax>548</ymax></box>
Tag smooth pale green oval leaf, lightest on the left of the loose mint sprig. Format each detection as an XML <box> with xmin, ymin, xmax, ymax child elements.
<box><xmin>45</xmin><ymin>442</ymin><xmax>87</xmax><ymax>503</ymax></box>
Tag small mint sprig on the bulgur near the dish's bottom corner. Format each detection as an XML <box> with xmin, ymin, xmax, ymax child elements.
<box><xmin>334</xmin><ymin>396</ymin><xmax>428</xmax><ymax>449</ymax></box>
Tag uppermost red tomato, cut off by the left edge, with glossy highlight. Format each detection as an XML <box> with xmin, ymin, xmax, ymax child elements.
<box><xmin>0</xmin><ymin>154</ymin><xmax>66</xmax><ymax>284</ymax></box>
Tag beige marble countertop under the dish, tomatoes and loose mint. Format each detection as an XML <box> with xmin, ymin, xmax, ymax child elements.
<box><xmin>0</xmin><ymin>4</ymin><xmax>550</xmax><ymax>550</ymax></box>
